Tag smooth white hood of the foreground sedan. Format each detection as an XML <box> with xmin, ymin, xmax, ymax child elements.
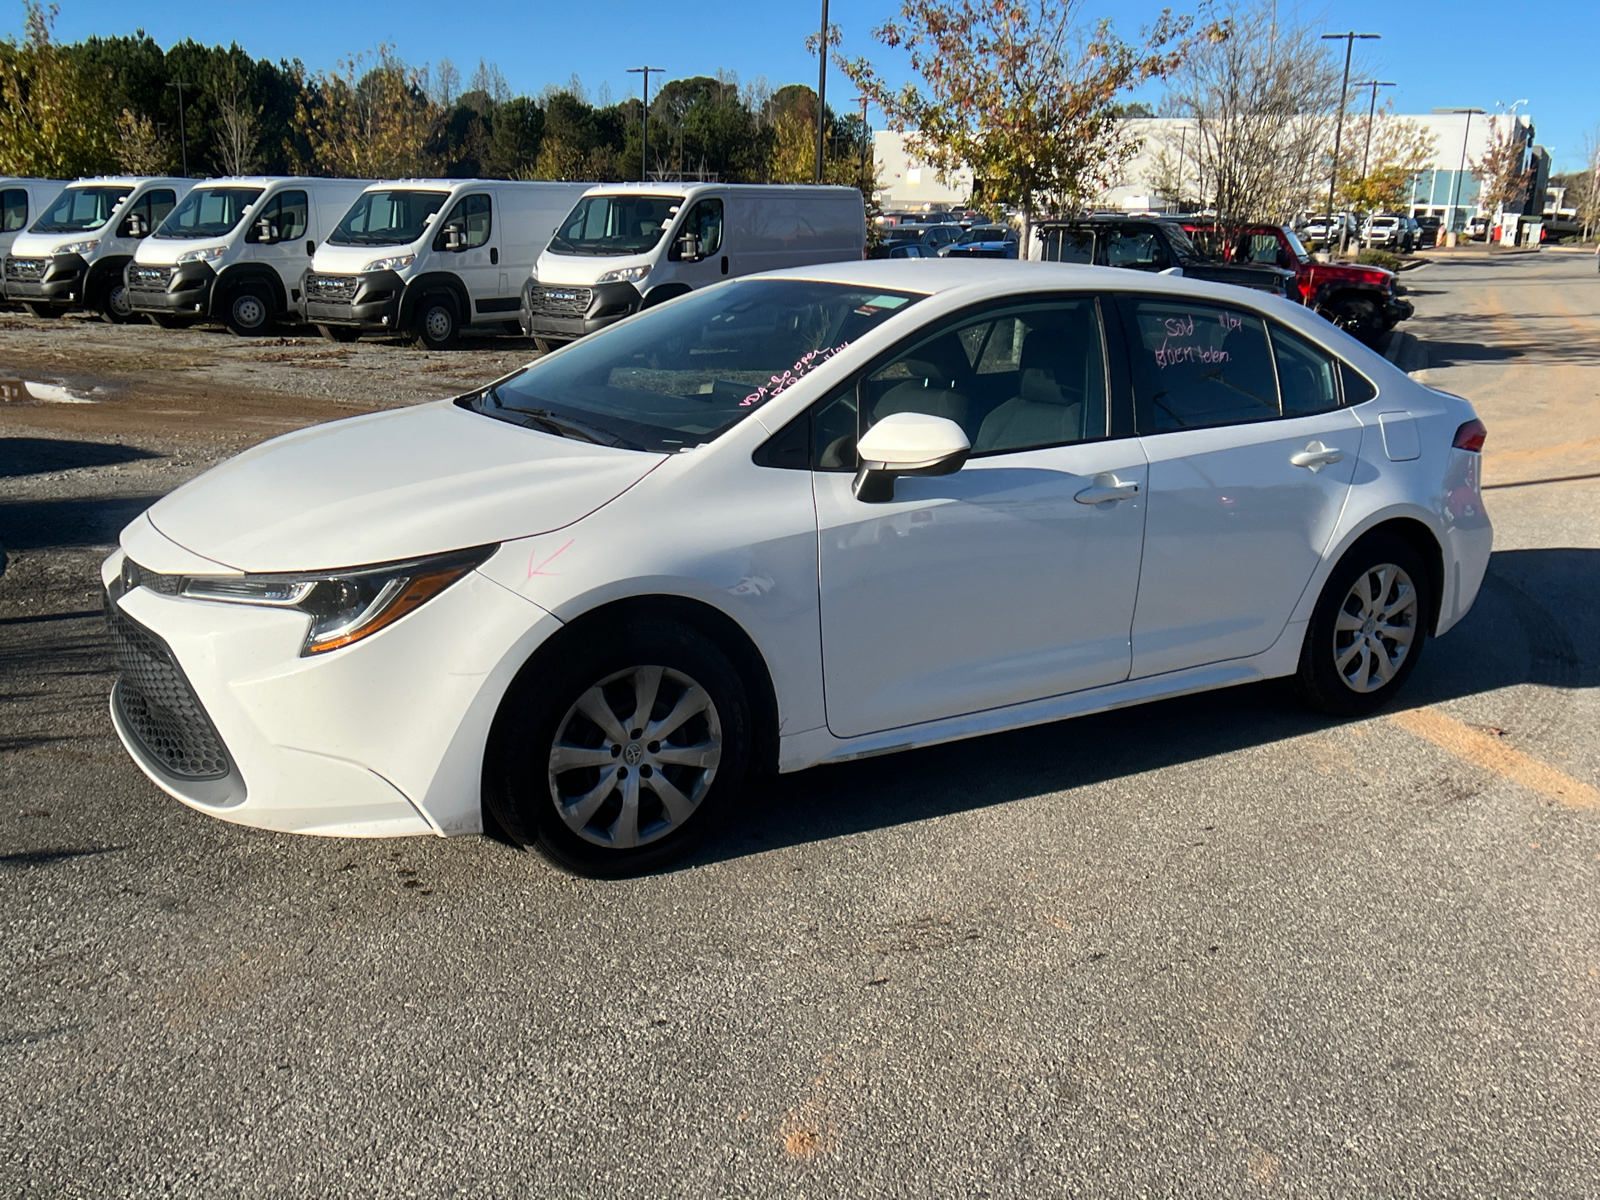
<box><xmin>139</xmin><ymin>400</ymin><xmax>667</xmax><ymax>571</ymax></box>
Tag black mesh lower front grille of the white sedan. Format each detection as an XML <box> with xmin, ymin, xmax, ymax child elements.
<box><xmin>106</xmin><ymin>595</ymin><xmax>234</xmax><ymax>779</ymax></box>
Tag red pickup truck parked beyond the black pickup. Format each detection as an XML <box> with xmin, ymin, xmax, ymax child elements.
<box><xmin>1182</xmin><ymin>221</ymin><xmax>1414</xmax><ymax>346</ymax></box>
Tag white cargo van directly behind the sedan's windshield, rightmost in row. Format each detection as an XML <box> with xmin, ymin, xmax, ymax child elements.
<box><xmin>520</xmin><ymin>184</ymin><xmax>867</xmax><ymax>349</ymax></box>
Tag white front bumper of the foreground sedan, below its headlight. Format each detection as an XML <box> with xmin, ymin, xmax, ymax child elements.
<box><xmin>102</xmin><ymin>550</ymin><xmax>560</xmax><ymax>837</ymax></box>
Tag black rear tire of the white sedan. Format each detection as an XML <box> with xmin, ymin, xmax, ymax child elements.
<box><xmin>1291</xmin><ymin>531</ymin><xmax>1434</xmax><ymax>717</ymax></box>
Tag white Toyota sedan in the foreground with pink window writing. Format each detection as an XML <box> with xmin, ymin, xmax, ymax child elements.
<box><xmin>104</xmin><ymin>261</ymin><xmax>1493</xmax><ymax>874</ymax></box>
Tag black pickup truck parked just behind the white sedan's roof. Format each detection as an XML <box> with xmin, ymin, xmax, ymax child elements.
<box><xmin>1034</xmin><ymin>216</ymin><xmax>1294</xmax><ymax>296</ymax></box>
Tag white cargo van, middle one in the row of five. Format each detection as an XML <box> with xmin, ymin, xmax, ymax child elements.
<box><xmin>126</xmin><ymin>176</ymin><xmax>371</xmax><ymax>336</ymax></box>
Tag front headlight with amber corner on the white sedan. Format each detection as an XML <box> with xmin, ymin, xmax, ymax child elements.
<box><xmin>178</xmin><ymin>546</ymin><xmax>499</xmax><ymax>656</ymax></box>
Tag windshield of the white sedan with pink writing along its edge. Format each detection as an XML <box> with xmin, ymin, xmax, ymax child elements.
<box><xmin>458</xmin><ymin>278</ymin><xmax>922</xmax><ymax>454</ymax></box>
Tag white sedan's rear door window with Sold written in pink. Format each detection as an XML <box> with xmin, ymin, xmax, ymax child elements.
<box><xmin>1125</xmin><ymin>299</ymin><xmax>1280</xmax><ymax>434</ymax></box>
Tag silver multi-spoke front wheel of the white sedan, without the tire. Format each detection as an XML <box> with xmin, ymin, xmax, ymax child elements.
<box><xmin>549</xmin><ymin>666</ymin><xmax>723</xmax><ymax>850</ymax></box>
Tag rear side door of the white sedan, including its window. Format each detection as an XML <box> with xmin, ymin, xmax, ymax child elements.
<box><xmin>1123</xmin><ymin>298</ymin><xmax>1362</xmax><ymax>678</ymax></box>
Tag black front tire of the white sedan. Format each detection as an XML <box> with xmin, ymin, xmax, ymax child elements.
<box><xmin>483</xmin><ymin>618</ymin><xmax>752</xmax><ymax>878</ymax></box>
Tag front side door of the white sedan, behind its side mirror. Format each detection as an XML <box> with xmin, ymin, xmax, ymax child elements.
<box><xmin>813</xmin><ymin>296</ymin><xmax>1146</xmax><ymax>738</ymax></box>
